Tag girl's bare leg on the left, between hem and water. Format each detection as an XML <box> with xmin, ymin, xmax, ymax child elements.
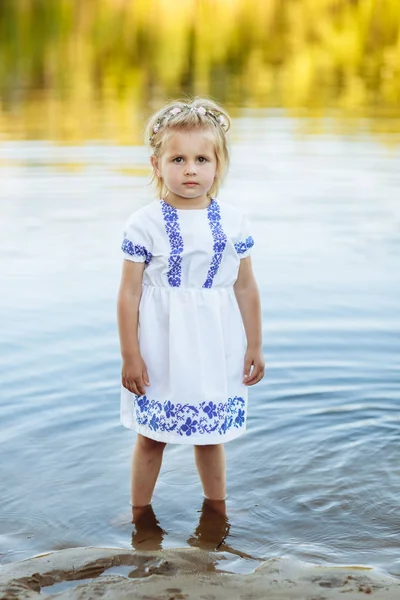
<box><xmin>131</xmin><ymin>434</ymin><xmax>166</xmax><ymax>512</ymax></box>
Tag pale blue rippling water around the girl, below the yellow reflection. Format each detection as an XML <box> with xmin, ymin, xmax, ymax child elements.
<box><xmin>0</xmin><ymin>114</ymin><xmax>400</xmax><ymax>575</ymax></box>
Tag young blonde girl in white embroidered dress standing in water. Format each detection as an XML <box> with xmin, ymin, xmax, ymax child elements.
<box><xmin>118</xmin><ymin>99</ymin><xmax>264</xmax><ymax>511</ymax></box>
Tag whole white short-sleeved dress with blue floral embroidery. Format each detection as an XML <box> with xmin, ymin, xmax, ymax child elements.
<box><xmin>121</xmin><ymin>200</ymin><xmax>254</xmax><ymax>444</ymax></box>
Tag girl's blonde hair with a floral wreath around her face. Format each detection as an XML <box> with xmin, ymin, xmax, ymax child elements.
<box><xmin>145</xmin><ymin>98</ymin><xmax>231</xmax><ymax>198</ymax></box>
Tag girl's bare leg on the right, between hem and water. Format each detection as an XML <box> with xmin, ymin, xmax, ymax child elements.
<box><xmin>194</xmin><ymin>444</ymin><xmax>226</xmax><ymax>501</ymax></box>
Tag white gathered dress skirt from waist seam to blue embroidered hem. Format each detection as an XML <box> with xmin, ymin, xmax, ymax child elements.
<box><xmin>121</xmin><ymin>284</ymin><xmax>247</xmax><ymax>444</ymax></box>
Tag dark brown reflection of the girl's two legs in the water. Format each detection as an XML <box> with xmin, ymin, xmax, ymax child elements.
<box><xmin>132</xmin><ymin>499</ymin><xmax>230</xmax><ymax>550</ymax></box>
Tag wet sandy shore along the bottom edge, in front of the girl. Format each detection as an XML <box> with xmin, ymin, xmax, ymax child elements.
<box><xmin>0</xmin><ymin>547</ymin><xmax>400</xmax><ymax>600</ymax></box>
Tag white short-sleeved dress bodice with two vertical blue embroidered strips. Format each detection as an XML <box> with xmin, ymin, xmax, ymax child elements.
<box><xmin>122</xmin><ymin>200</ymin><xmax>254</xmax><ymax>289</ymax></box>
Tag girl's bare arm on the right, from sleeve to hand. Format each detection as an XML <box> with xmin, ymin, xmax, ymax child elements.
<box><xmin>234</xmin><ymin>256</ymin><xmax>265</xmax><ymax>385</ymax></box>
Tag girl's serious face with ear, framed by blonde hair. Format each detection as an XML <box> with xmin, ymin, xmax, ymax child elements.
<box><xmin>151</xmin><ymin>129</ymin><xmax>217</xmax><ymax>206</ymax></box>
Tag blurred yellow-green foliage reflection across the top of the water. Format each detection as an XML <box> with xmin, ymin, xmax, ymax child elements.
<box><xmin>0</xmin><ymin>0</ymin><xmax>400</xmax><ymax>143</ymax></box>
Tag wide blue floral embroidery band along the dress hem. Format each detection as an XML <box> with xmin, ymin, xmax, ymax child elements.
<box><xmin>133</xmin><ymin>395</ymin><xmax>246</xmax><ymax>437</ymax></box>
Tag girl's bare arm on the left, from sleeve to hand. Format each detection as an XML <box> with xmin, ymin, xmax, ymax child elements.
<box><xmin>118</xmin><ymin>260</ymin><xmax>150</xmax><ymax>396</ymax></box>
